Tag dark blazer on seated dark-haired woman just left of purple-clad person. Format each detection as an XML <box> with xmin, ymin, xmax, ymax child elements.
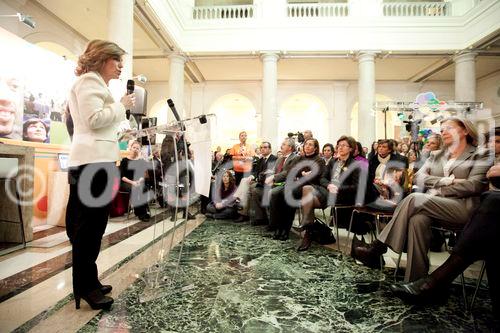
<box><xmin>321</xmin><ymin>156</ymin><xmax>366</xmax><ymax>205</ymax></box>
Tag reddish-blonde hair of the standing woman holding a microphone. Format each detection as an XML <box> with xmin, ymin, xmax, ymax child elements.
<box><xmin>75</xmin><ymin>39</ymin><xmax>127</xmax><ymax>76</ymax></box>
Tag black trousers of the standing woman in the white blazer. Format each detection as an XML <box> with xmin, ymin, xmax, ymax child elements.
<box><xmin>66</xmin><ymin>162</ymin><xmax>120</xmax><ymax>295</ymax></box>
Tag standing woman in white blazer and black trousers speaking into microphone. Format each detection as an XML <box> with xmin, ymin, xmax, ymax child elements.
<box><xmin>66</xmin><ymin>40</ymin><xmax>135</xmax><ymax>309</ymax></box>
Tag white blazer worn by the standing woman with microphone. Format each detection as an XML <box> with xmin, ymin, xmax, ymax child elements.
<box><xmin>69</xmin><ymin>72</ymin><xmax>126</xmax><ymax>167</ymax></box>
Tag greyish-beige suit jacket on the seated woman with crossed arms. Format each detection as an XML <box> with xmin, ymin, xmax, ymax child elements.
<box><xmin>416</xmin><ymin>145</ymin><xmax>493</xmax><ymax>209</ymax></box>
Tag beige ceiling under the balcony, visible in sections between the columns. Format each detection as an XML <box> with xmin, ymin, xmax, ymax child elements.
<box><xmin>38</xmin><ymin>0</ymin><xmax>500</xmax><ymax>82</ymax></box>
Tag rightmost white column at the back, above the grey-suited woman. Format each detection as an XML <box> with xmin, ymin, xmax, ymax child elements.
<box><xmin>453</xmin><ymin>52</ymin><xmax>477</xmax><ymax>102</ymax></box>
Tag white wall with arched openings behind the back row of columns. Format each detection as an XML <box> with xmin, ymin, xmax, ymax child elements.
<box><xmin>146</xmin><ymin>81</ymin><xmax>458</xmax><ymax>147</ymax></box>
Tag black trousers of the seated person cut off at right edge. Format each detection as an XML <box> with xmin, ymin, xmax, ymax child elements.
<box><xmin>453</xmin><ymin>191</ymin><xmax>500</xmax><ymax>320</ymax></box>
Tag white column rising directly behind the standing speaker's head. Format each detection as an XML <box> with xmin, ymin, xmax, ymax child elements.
<box><xmin>107</xmin><ymin>0</ymin><xmax>134</xmax><ymax>82</ymax></box>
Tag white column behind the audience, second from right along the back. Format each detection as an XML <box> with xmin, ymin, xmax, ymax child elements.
<box><xmin>356</xmin><ymin>52</ymin><xmax>375</xmax><ymax>147</ymax></box>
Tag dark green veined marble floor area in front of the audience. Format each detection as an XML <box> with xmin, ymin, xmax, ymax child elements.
<box><xmin>80</xmin><ymin>220</ymin><xmax>491</xmax><ymax>332</ymax></box>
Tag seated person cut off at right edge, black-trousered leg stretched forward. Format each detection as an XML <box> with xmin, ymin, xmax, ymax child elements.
<box><xmin>390</xmin><ymin>162</ymin><xmax>500</xmax><ymax>330</ymax></box>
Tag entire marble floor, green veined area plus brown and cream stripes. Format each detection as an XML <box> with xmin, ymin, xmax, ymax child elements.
<box><xmin>0</xmin><ymin>211</ymin><xmax>491</xmax><ymax>332</ymax></box>
